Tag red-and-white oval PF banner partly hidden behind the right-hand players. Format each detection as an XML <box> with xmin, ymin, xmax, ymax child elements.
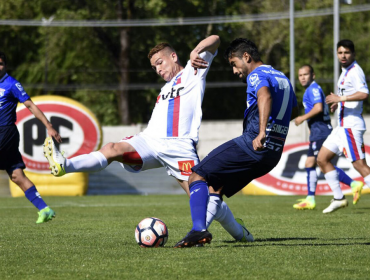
<box><xmin>253</xmin><ymin>143</ymin><xmax>370</xmax><ymax>195</ymax></box>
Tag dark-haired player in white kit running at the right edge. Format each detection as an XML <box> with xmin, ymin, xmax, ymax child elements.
<box><xmin>317</xmin><ymin>40</ymin><xmax>370</xmax><ymax>213</ymax></box>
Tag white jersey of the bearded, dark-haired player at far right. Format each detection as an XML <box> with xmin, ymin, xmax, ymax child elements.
<box><xmin>337</xmin><ymin>61</ymin><xmax>369</xmax><ymax>130</ymax></box>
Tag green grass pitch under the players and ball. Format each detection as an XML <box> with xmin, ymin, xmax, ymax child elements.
<box><xmin>0</xmin><ymin>195</ymin><xmax>370</xmax><ymax>280</ymax></box>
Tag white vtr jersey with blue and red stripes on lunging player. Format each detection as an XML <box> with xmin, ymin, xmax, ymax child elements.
<box><xmin>143</xmin><ymin>51</ymin><xmax>217</xmax><ymax>143</ymax></box>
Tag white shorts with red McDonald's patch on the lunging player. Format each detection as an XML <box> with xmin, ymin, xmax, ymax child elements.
<box><xmin>120</xmin><ymin>132</ymin><xmax>199</xmax><ymax>181</ymax></box>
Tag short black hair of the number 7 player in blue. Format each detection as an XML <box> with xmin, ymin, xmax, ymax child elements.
<box><xmin>224</xmin><ymin>38</ymin><xmax>261</xmax><ymax>62</ymax></box>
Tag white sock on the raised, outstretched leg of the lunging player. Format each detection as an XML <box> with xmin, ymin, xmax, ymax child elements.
<box><xmin>65</xmin><ymin>151</ymin><xmax>108</xmax><ymax>173</ymax></box>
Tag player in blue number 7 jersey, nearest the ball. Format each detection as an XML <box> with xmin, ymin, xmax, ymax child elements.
<box><xmin>175</xmin><ymin>38</ymin><xmax>298</xmax><ymax>248</ymax></box>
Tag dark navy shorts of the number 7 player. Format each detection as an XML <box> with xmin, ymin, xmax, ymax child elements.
<box><xmin>192</xmin><ymin>140</ymin><xmax>276</xmax><ymax>197</ymax></box>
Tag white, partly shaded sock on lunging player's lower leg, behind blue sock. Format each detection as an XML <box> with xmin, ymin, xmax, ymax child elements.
<box><xmin>206</xmin><ymin>195</ymin><xmax>244</xmax><ymax>240</ymax></box>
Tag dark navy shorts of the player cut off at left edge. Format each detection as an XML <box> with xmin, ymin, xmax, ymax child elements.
<box><xmin>0</xmin><ymin>125</ymin><xmax>26</xmax><ymax>175</ymax></box>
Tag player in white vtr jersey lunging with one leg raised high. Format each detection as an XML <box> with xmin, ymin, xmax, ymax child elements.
<box><xmin>44</xmin><ymin>35</ymin><xmax>250</xmax><ymax>242</ymax></box>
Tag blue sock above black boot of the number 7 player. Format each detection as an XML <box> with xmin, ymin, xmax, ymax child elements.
<box><xmin>189</xmin><ymin>180</ymin><xmax>209</xmax><ymax>231</ymax></box>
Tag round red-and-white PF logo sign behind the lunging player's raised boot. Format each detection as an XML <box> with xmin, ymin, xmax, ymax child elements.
<box><xmin>16</xmin><ymin>96</ymin><xmax>102</xmax><ymax>173</ymax></box>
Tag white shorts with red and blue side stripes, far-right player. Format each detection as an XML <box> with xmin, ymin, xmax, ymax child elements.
<box><xmin>323</xmin><ymin>126</ymin><xmax>365</xmax><ymax>162</ymax></box>
